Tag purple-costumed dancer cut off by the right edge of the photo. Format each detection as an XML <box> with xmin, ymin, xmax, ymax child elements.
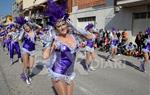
<box><xmin>139</xmin><ymin>28</ymin><xmax>150</xmax><ymax>72</ymax></box>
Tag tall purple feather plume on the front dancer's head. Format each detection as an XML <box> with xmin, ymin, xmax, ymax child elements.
<box><xmin>46</xmin><ymin>0</ymin><xmax>69</xmax><ymax>26</ymax></box>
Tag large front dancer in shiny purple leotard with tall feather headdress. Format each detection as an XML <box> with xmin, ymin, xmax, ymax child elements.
<box><xmin>43</xmin><ymin>0</ymin><xmax>93</xmax><ymax>95</ymax></box>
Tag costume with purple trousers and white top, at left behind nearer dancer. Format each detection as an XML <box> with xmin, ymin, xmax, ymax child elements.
<box><xmin>8</xmin><ymin>24</ymin><xmax>21</xmax><ymax>59</ymax></box>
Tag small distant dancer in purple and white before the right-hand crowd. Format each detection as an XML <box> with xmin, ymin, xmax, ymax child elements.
<box><xmin>106</xmin><ymin>28</ymin><xmax>119</xmax><ymax>62</ymax></box>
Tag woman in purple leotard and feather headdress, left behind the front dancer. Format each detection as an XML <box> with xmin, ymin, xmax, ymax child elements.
<box><xmin>16</xmin><ymin>17</ymin><xmax>41</xmax><ymax>84</ymax></box>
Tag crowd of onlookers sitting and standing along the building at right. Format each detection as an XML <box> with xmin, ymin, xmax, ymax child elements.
<box><xmin>95</xmin><ymin>29</ymin><xmax>149</xmax><ymax>57</ymax></box>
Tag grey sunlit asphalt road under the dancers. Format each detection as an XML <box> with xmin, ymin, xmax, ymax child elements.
<box><xmin>0</xmin><ymin>42</ymin><xmax>150</xmax><ymax>95</ymax></box>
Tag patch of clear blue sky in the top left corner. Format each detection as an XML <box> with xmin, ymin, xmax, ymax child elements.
<box><xmin>0</xmin><ymin>0</ymin><xmax>15</xmax><ymax>16</ymax></box>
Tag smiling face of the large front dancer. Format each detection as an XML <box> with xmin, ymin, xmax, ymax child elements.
<box><xmin>56</xmin><ymin>21</ymin><xmax>69</xmax><ymax>35</ymax></box>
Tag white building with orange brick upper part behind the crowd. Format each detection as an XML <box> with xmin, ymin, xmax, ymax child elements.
<box><xmin>71</xmin><ymin>0</ymin><xmax>150</xmax><ymax>41</ymax></box>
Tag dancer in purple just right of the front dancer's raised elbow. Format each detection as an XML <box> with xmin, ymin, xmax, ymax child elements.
<box><xmin>85</xmin><ymin>24</ymin><xmax>96</xmax><ymax>71</ymax></box>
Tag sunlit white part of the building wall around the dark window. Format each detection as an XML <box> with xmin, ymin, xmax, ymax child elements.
<box><xmin>71</xmin><ymin>0</ymin><xmax>114</xmax><ymax>29</ymax></box>
